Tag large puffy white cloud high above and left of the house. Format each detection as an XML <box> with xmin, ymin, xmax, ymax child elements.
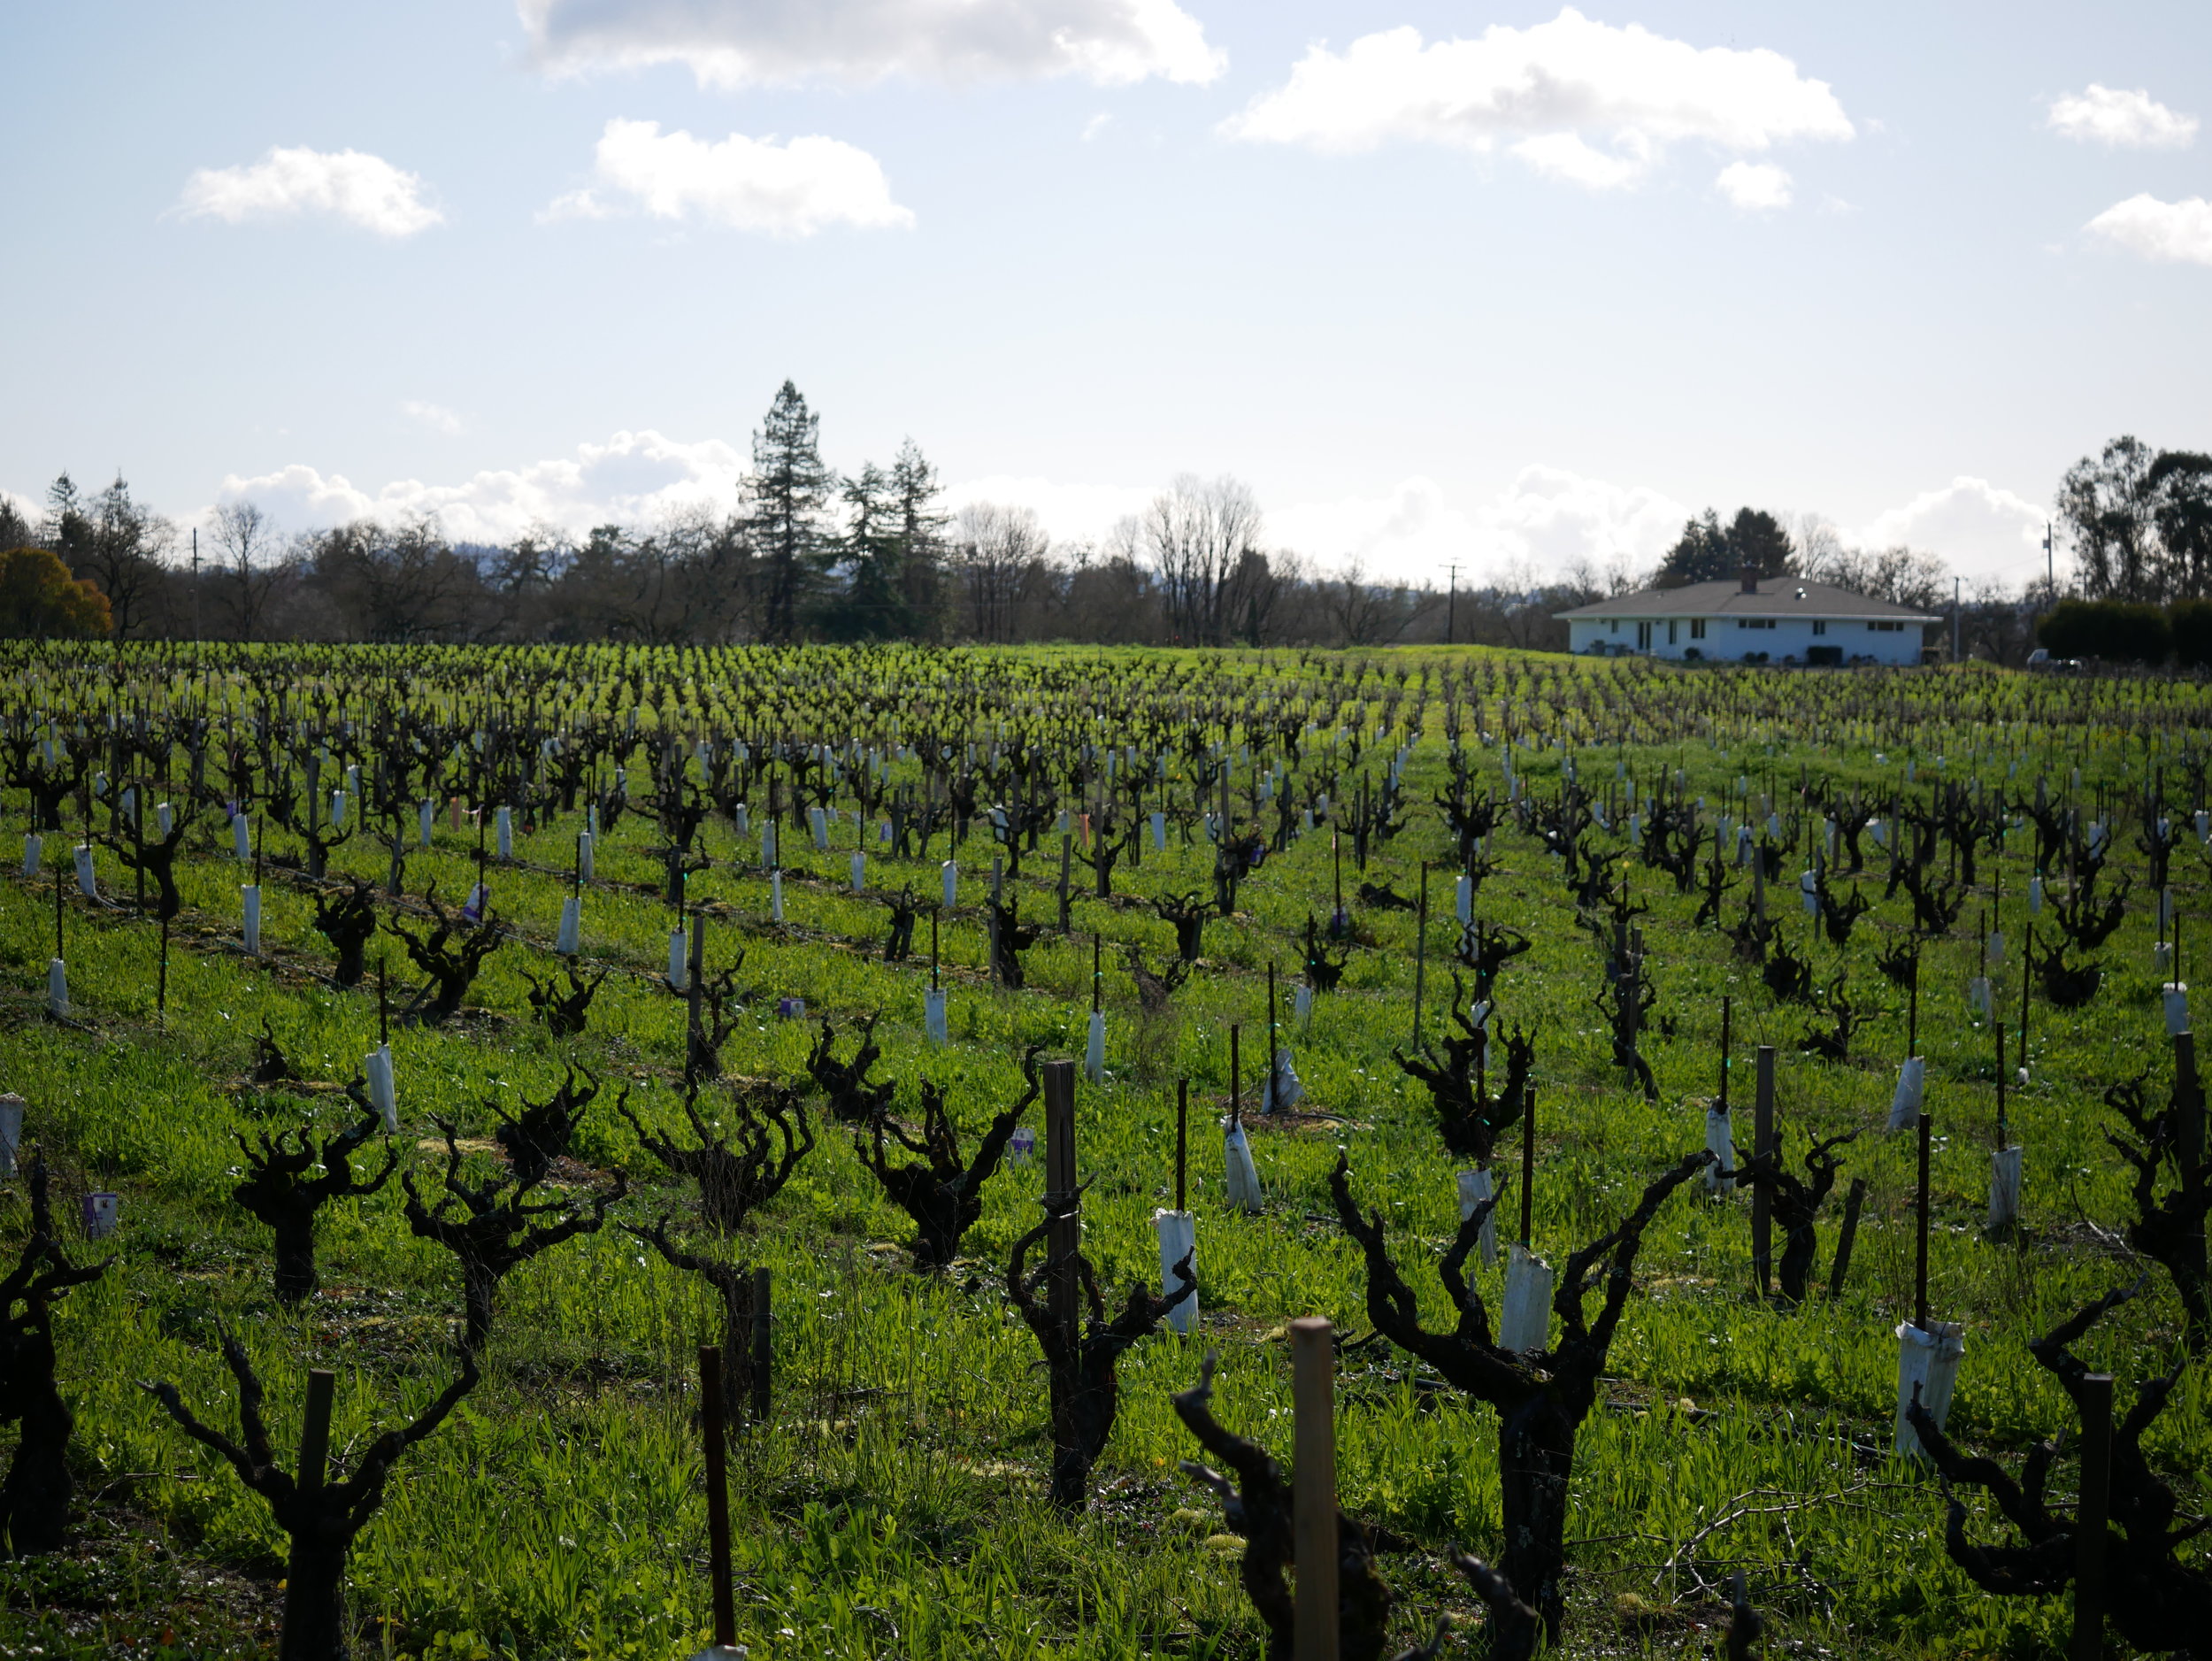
<box><xmin>1221</xmin><ymin>6</ymin><xmax>1852</xmax><ymax>188</ymax></box>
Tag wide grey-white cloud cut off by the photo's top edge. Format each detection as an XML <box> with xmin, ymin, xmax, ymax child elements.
<box><xmin>518</xmin><ymin>0</ymin><xmax>1224</xmax><ymax>88</ymax></box>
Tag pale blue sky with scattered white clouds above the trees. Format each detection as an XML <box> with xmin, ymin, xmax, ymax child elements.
<box><xmin>0</xmin><ymin>0</ymin><xmax>2212</xmax><ymax>581</ymax></box>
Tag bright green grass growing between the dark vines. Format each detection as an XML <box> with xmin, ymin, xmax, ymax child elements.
<box><xmin>0</xmin><ymin>652</ymin><xmax>2212</xmax><ymax>1661</ymax></box>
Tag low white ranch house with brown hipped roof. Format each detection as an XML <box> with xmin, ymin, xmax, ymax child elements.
<box><xmin>1553</xmin><ymin>575</ymin><xmax>1942</xmax><ymax>664</ymax></box>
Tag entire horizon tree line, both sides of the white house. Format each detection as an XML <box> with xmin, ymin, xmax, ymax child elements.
<box><xmin>0</xmin><ymin>393</ymin><xmax>2185</xmax><ymax>664</ymax></box>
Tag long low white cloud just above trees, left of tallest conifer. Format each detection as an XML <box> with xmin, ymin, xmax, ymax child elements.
<box><xmin>217</xmin><ymin>429</ymin><xmax>746</xmax><ymax>542</ymax></box>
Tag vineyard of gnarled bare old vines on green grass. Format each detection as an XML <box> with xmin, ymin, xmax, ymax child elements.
<box><xmin>0</xmin><ymin>643</ymin><xmax>2212</xmax><ymax>1661</ymax></box>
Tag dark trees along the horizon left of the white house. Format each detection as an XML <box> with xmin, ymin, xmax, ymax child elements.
<box><xmin>0</xmin><ymin>382</ymin><xmax>1601</xmax><ymax>648</ymax></box>
